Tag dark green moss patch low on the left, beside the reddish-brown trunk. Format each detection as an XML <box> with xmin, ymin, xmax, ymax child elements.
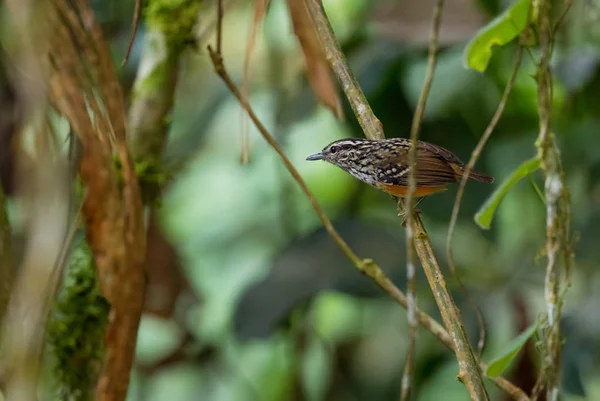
<box><xmin>47</xmin><ymin>239</ymin><xmax>110</xmax><ymax>401</ymax></box>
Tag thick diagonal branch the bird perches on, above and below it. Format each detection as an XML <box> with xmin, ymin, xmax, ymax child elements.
<box><xmin>306</xmin><ymin>0</ymin><xmax>489</xmax><ymax>400</ymax></box>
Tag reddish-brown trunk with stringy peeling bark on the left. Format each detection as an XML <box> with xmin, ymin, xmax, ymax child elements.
<box><xmin>50</xmin><ymin>0</ymin><xmax>150</xmax><ymax>401</ymax></box>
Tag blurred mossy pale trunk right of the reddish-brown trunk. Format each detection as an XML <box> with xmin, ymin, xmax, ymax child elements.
<box><xmin>127</xmin><ymin>0</ymin><xmax>202</xmax><ymax>328</ymax></box>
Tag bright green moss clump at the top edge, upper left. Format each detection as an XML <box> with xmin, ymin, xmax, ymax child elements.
<box><xmin>144</xmin><ymin>0</ymin><xmax>202</xmax><ymax>46</ymax></box>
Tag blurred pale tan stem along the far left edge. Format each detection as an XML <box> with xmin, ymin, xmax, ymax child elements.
<box><xmin>1</xmin><ymin>0</ymin><xmax>69</xmax><ymax>401</ymax></box>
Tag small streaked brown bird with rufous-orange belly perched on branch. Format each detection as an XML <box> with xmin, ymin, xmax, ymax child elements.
<box><xmin>306</xmin><ymin>138</ymin><xmax>494</xmax><ymax>198</ymax></box>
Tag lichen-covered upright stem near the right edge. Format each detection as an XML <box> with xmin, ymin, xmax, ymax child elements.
<box><xmin>534</xmin><ymin>0</ymin><xmax>572</xmax><ymax>401</ymax></box>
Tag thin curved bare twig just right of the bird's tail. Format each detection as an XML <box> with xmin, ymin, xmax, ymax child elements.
<box><xmin>446</xmin><ymin>46</ymin><xmax>523</xmax><ymax>357</ymax></box>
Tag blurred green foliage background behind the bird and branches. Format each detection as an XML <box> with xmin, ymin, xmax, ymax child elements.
<box><xmin>52</xmin><ymin>0</ymin><xmax>600</xmax><ymax>401</ymax></box>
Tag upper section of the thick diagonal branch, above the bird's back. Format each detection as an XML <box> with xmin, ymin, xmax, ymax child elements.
<box><xmin>304</xmin><ymin>0</ymin><xmax>385</xmax><ymax>139</ymax></box>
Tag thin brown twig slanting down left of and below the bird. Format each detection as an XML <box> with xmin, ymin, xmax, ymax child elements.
<box><xmin>208</xmin><ymin>42</ymin><xmax>528</xmax><ymax>401</ymax></box>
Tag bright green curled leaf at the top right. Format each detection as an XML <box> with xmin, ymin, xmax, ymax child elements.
<box><xmin>464</xmin><ymin>0</ymin><xmax>531</xmax><ymax>72</ymax></box>
